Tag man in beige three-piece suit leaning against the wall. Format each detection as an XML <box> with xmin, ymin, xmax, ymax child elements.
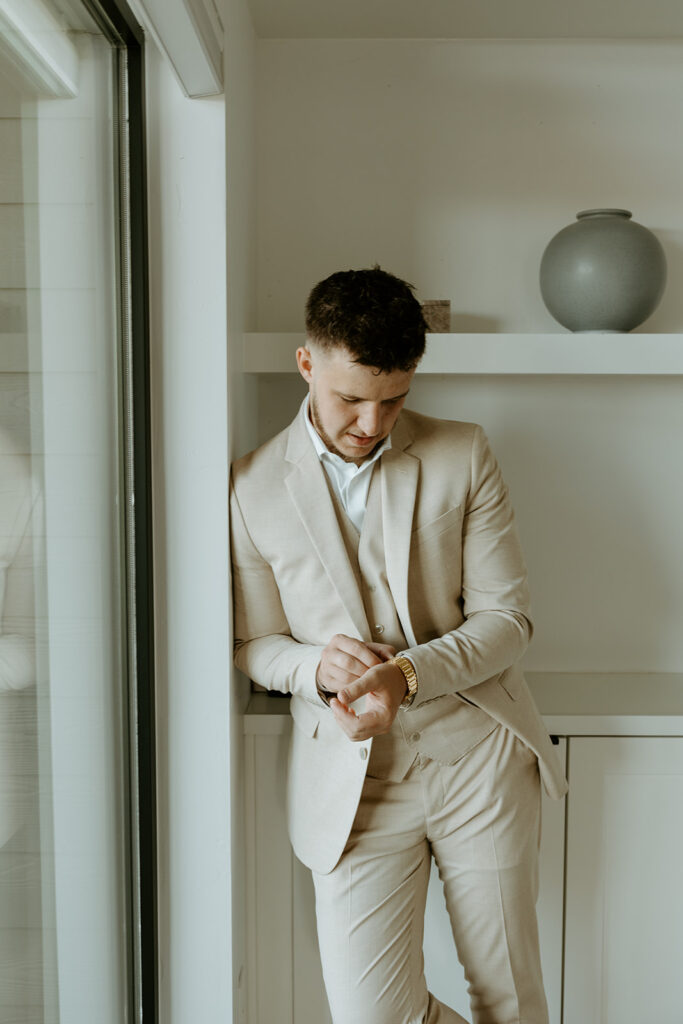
<box><xmin>230</xmin><ymin>267</ymin><xmax>566</xmax><ymax>1024</ymax></box>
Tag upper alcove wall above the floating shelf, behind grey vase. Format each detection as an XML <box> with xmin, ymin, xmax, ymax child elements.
<box><xmin>257</xmin><ymin>40</ymin><xmax>683</xmax><ymax>332</ymax></box>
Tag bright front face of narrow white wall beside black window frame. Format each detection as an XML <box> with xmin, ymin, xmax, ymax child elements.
<box><xmin>147</xmin><ymin>39</ymin><xmax>233</xmax><ymax>1024</ymax></box>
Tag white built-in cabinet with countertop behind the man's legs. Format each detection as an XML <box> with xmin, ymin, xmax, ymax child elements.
<box><xmin>245</xmin><ymin>674</ymin><xmax>683</xmax><ymax>1024</ymax></box>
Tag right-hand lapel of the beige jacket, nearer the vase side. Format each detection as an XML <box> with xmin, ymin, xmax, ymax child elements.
<box><xmin>382</xmin><ymin>416</ymin><xmax>420</xmax><ymax>646</ymax></box>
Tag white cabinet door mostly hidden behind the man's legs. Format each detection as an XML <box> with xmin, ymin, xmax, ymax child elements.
<box><xmin>424</xmin><ymin>739</ymin><xmax>566</xmax><ymax>1024</ymax></box>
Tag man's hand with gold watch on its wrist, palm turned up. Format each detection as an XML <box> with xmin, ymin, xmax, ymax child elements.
<box><xmin>330</xmin><ymin>663</ymin><xmax>408</xmax><ymax>742</ymax></box>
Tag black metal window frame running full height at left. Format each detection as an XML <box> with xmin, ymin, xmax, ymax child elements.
<box><xmin>83</xmin><ymin>0</ymin><xmax>159</xmax><ymax>1024</ymax></box>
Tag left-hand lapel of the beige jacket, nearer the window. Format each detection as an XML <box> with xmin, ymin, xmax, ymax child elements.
<box><xmin>285</xmin><ymin>413</ymin><xmax>371</xmax><ymax>640</ymax></box>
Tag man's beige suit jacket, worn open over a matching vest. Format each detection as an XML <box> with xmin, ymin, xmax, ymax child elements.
<box><xmin>230</xmin><ymin>410</ymin><xmax>566</xmax><ymax>873</ymax></box>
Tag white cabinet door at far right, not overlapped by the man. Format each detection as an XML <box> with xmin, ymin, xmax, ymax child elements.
<box><xmin>564</xmin><ymin>737</ymin><xmax>683</xmax><ymax>1024</ymax></box>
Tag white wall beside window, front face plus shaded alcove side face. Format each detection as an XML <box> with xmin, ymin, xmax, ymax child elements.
<box><xmin>147</xmin><ymin>0</ymin><xmax>256</xmax><ymax>1011</ymax></box>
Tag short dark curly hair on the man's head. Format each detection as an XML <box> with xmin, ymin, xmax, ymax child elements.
<box><xmin>306</xmin><ymin>265</ymin><xmax>427</xmax><ymax>373</ymax></box>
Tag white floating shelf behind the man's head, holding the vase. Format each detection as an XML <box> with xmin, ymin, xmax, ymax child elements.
<box><xmin>243</xmin><ymin>333</ymin><xmax>683</xmax><ymax>376</ymax></box>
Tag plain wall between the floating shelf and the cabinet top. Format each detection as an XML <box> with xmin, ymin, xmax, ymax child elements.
<box><xmin>250</xmin><ymin>366</ymin><xmax>683</xmax><ymax>672</ymax></box>
